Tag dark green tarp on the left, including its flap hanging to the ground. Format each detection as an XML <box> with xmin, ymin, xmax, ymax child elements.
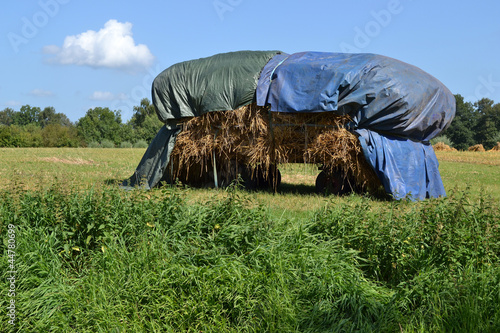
<box><xmin>122</xmin><ymin>51</ymin><xmax>281</xmax><ymax>189</ymax></box>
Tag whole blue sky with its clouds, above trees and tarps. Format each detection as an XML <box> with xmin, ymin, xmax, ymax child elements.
<box><xmin>0</xmin><ymin>0</ymin><xmax>500</xmax><ymax>121</ymax></box>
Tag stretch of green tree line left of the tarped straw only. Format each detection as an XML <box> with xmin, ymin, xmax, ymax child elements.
<box><xmin>0</xmin><ymin>98</ymin><xmax>163</xmax><ymax>148</ymax></box>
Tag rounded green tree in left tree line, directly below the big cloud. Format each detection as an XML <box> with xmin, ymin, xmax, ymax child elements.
<box><xmin>76</xmin><ymin>107</ymin><xmax>122</xmax><ymax>144</ymax></box>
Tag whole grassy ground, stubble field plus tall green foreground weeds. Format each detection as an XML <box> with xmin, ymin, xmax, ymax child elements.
<box><xmin>0</xmin><ymin>148</ymin><xmax>500</xmax><ymax>332</ymax></box>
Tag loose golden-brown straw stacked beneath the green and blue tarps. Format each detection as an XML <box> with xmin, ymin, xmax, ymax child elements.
<box><xmin>170</xmin><ymin>103</ymin><xmax>380</xmax><ymax>190</ymax></box>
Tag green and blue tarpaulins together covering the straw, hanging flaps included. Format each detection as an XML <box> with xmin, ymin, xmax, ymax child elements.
<box><xmin>126</xmin><ymin>51</ymin><xmax>455</xmax><ymax>199</ymax></box>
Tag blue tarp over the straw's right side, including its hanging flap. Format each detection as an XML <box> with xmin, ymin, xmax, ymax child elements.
<box><xmin>256</xmin><ymin>52</ymin><xmax>455</xmax><ymax>199</ymax></box>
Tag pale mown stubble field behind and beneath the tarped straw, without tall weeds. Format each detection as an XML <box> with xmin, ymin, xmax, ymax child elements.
<box><xmin>0</xmin><ymin>148</ymin><xmax>500</xmax><ymax>204</ymax></box>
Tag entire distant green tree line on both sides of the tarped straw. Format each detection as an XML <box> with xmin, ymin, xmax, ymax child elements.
<box><xmin>0</xmin><ymin>94</ymin><xmax>500</xmax><ymax>150</ymax></box>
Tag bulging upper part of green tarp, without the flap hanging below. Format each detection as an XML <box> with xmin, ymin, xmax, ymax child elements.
<box><xmin>152</xmin><ymin>51</ymin><xmax>280</xmax><ymax>123</ymax></box>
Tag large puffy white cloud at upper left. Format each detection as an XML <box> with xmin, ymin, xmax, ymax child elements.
<box><xmin>43</xmin><ymin>20</ymin><xmax>154</xmax><ymax>69</ymax></box>
